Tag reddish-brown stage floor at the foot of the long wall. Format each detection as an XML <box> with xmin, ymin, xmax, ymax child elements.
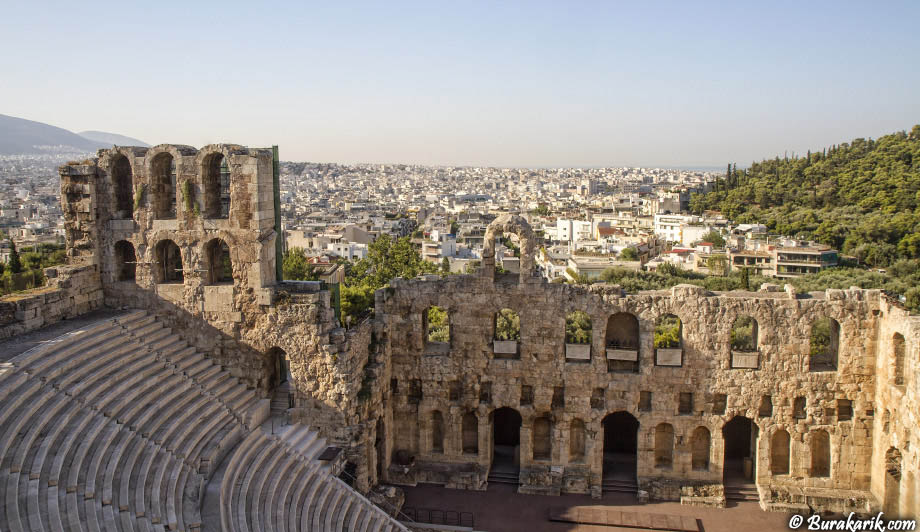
<box><xmin>403</xmin><ymin>485</ymin><xmax>789</xmax><ymax>532</ymax></box>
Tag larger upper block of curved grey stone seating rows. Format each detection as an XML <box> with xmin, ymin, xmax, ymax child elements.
<box><xmin>0</xmin><ymin>311</ymin><xmax>268</xmax><ymax>531</ymax></box>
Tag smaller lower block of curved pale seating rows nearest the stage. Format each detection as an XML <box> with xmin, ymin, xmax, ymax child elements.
<box><xmin>220</xmin><ymin>426</ymin><xmax>408</xmax><ymax>532</ymax></box>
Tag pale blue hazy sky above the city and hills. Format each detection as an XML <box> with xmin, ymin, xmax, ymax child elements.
<box><xmin>0</xmin><ymin>0</ymin><xmax>920</xmax><ymax>166</ymax></box>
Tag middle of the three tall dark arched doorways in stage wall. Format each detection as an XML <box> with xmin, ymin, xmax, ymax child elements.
<box><xmin>601</xmin><ymin>411</ymin><xmax>639</xmax><ymax>491</ymax></box>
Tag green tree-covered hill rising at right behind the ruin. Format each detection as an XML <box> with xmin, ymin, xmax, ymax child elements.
<box><xmin>690</xmin><ymin>125</ymin><xmax>920</xmax><ymax>266</ymax></box>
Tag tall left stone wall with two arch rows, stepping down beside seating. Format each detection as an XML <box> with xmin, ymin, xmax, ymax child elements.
<box><xmin>50</xmin><ymin>144</ymin><xmax>385</xmax><ymax>489</ymax></box>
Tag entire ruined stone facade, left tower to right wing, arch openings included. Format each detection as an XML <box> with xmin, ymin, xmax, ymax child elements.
<box><xmin>0</xmin><ymin>145</ymin><xmax>920</xmax><ymax>516</ymax></box>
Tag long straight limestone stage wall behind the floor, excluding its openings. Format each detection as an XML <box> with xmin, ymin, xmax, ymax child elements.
<box><xmin>377</xmin><ymin>276</ymin><xmax>880</xmax><ymax>504</ymax></box>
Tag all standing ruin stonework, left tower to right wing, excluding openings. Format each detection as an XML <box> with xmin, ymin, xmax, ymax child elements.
<box><xmin>0</xmin><ymin>152</ymin><xmax>920</xmax><ymax>515</ymax></box>
